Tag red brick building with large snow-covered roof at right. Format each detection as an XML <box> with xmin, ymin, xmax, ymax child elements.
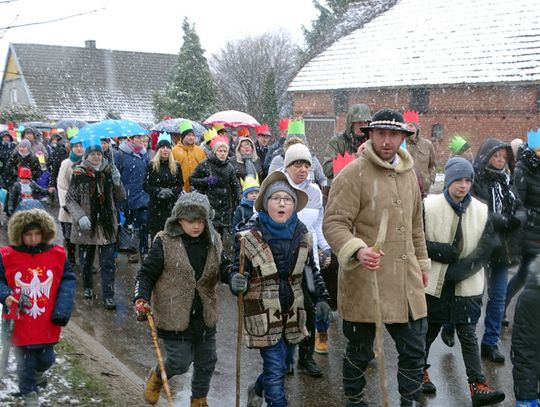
<box><xmin>288</xmin><ymin>0</ymin><xmax>540</xmax><ymax>165</ymax></box>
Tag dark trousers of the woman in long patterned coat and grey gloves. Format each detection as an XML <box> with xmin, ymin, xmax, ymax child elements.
<box><xmin>79</xmin><ymin>244</ymin><xmax>116</xmax><ymax>299</ymax></box>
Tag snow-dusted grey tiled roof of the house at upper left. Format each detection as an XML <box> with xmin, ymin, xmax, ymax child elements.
<box><xmin>10</xmin><ymin>44</ymin><xmax>178</xmax><ymax>122</ymax></box>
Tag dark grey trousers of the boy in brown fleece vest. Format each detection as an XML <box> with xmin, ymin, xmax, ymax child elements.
<box><xmin>156</xmin><ymin>331</ymin><xmax>217</xmax><ymax>399</ymax></box>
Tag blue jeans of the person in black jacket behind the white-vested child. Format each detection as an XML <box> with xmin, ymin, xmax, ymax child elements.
<box><xmin>482</xmin><ymin>263</ymin><xmax>508</xmax><ymax>346</ymax></box>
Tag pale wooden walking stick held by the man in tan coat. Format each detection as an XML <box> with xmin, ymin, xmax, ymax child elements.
<box><xmin>371</xmin><ymin>208</ymin><xmax>389</xmax><ymax>407</ymax></box>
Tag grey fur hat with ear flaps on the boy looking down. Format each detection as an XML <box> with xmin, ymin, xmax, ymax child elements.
<box><xmin>163</xmin><ymin>191</ymin><xmax>215</xmax><ymax>242</ymax></box>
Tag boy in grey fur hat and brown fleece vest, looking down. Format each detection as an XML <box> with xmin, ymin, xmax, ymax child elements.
<box><xmin>135</xmin><ymin>192</ymin><xmax>227</xmax><ymax>407</ymax></box>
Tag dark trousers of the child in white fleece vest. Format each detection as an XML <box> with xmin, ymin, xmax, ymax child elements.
<box><xmin>426</xmin><ymin>322</ymin><xmax>486</xmax><ymax>383</ymax></box>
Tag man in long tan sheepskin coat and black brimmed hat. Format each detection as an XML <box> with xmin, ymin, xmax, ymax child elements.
<box><xmin>323</xmin><ymin>109</ymin><xmax>430</xmax><ymax>407</ymax></box>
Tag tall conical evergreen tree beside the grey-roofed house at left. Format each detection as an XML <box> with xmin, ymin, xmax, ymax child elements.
<box><xmin>154</xmin><ymin>18</ymin><xmax>217</xmax><ymax>121</ymax></box>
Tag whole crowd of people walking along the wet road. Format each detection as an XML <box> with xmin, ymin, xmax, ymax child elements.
<box><xmin>0</xmin><ymin>110</ymin><xmax>540</xmax><ymax>407</ymax></box>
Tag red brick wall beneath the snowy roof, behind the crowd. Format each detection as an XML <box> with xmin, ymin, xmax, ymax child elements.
<box><xmin>293</xmin><ymin>85</ymin><xmax>540</xmax><ymax>166</ymax></box>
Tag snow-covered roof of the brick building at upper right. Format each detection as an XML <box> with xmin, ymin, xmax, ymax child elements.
<box><xmin>288</xmin><ymin>0</ymin><xmax>540</xmax><ymax>92</ymax></box>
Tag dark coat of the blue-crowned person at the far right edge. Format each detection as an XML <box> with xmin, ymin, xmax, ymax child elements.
<box><xmin>513</xmin><ymin>145</ymin><xmax>540</xmax><ymax>255</ymax></box>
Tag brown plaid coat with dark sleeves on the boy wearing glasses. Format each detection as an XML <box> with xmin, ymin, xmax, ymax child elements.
<box><xmin>229</xmin><ymin>218</ymin><xmax>329</xmax><ymax>348</ymax></box>
